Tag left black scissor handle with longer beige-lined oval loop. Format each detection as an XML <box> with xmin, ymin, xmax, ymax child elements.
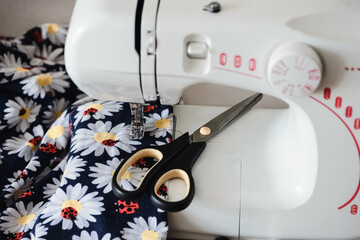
<box><xmin>112</xmin><ymin>133</ymin><xmax>189</xmax><ymax>201</ymax></box>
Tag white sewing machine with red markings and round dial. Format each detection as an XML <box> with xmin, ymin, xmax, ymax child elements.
<box><xmin>65</xmin><ymin>0</ymin><xmax>360</xmax><ymax>239</ymax></box>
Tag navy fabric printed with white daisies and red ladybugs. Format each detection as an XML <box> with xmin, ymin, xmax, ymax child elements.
<box><xmin>0</xmin><ymin>24</ymin><xmax>172</xmax><ymax>240</ymax></box>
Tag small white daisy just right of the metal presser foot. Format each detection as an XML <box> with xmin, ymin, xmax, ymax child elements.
<box><xmin>144</xmin><ymin>109</ymin><xmax>173</xmax><ymax>138</ymax></box>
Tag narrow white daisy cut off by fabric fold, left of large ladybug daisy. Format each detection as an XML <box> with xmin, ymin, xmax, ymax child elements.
<box><xmin>43</xmin><ymin>112</ymin><xmax>70</xmax><ymax>149</ymax></box>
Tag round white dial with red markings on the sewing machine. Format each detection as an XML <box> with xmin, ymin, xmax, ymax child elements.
<box><xmin>268</xmin><ymin>43</ymin><xmax>322</xmax><ymax>97</ymax></box>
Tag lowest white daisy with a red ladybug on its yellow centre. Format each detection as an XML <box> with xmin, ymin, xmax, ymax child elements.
<box><xmin>41</xmin><ymin>183</ymin><xmax>105</xmax><ymax>230</ymax></box>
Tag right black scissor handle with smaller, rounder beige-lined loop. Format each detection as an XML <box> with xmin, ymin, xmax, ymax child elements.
<box><xmin>150</xmin><ymin>142</ymin><xmax>206</xmax><ymax>212</ymax></box>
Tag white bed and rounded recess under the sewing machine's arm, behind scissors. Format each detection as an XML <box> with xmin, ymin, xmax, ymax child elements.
<box><xmin>168</xmin><ymin>106</ymin><xmax>317</xmax><ymax>237</ymax></box>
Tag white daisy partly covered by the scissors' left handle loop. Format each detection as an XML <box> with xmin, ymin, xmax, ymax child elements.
<box><xmin>89</xmin><ymin>157</ymin><xmax>149</xmax><ymax>193</ymax></box>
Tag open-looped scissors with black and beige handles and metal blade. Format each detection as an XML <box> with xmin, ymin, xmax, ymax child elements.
<box><xmin>112</xmin><ymin>93</ymin><xmax>262</xmax><ymax>212</ymax></box>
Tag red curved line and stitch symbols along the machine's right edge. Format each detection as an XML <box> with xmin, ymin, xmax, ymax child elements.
<box><xmin>310</xmin><ymin>87</ymin><xmax>360</xmax><ymax>215</ymax></box>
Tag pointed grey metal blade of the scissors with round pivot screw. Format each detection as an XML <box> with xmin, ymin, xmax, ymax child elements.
<box><xmin>190</xmin><ymin>93</ymin><xmax>263</xmax><ymax>142</ymax></box>
